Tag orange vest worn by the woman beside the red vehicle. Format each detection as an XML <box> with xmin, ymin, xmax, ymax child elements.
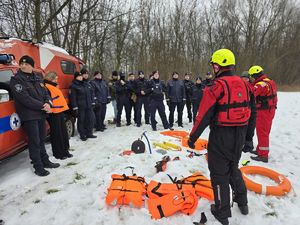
<box><xmin>45</xmin><ymin>83</ymin><xmax>69</xmax><ymax>113</ymax></box>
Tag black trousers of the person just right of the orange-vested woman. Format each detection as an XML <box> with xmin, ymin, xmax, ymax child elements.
<box><xmin>77</xmin><ymin>108</ymin><xmax>95</xmax><ymax>137</ymax></box>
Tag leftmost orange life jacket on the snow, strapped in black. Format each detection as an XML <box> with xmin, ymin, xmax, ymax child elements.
<box><xmin>105</xmin><ymin>174</ymin><xmax>146</xmax><ymax>207</ymax></box>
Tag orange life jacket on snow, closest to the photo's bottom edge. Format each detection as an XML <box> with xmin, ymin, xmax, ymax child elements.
<box><xmin>148</xmin><ymin>190</ymin><xmax>198</xmax><ymax>219</ymax></box>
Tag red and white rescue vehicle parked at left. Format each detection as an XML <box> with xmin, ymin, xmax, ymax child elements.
<box><xmin>0</xmin><ymin>38</ymin><xmax>84</xmax><ymax>160</ymax></box>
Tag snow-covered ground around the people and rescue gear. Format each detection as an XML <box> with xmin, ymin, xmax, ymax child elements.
<box><xmin>0</xmin><ymin>93</ymin><xmax>300</xmax><ymax>225</ymax></box>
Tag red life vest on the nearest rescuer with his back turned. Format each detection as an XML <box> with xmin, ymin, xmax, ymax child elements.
<box><xmin>215</xmin><ymin>76</ymin><xmax>251</xmax><ymax>126</ymax></box>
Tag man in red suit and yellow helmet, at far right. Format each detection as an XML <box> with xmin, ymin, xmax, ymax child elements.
<box><xmin>249</xmin><ymin>65</ymin><xmax>277</xmax><ymax>163</ymax></box>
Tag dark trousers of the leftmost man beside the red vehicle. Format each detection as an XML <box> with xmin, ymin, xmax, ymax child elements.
<box><xmin>23</xmin><ymin>119</ymin><xmax>49</xmax><ymax>170</ymax></box>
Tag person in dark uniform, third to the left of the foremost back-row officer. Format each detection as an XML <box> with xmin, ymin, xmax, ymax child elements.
<box><xmin>116</xmin><ymin>72</ymin><xmax>131</xmax><ymax>127</ymax></box>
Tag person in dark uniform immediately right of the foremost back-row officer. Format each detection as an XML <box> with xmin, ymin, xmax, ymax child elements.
<box><xmin>166</xmin><ymin>72</ymin><xmax>186</xmax><ymax>127</ymax></box>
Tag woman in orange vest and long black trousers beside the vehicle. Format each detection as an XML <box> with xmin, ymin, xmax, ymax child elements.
<box><xmin>44</xmin><ymin>71</ymin><xmax>73</xmax><ymax>159</ymax></box>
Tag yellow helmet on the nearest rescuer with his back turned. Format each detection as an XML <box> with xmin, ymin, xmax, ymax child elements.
<box><xmin>210</xmin><ymin>48</ymin><xmax>235</xmax><ymax>67</ymax></box>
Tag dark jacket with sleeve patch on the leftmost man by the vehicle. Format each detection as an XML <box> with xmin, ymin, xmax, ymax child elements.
<box><xmin>10</xmin><ymin>70</ymin><xmax>51</xmax><ymax>121</ymax></box>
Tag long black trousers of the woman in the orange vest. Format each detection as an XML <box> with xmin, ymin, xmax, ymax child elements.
<box><xmin>47</xmin><ymin>113</ymin><xmax>70</xmax><ymax>159</ymax></box>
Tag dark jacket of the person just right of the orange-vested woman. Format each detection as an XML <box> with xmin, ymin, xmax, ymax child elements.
<box><xmin>70</xmin><ymin>80</ymin><xmax>95</xmax><ymax>110</ymax></box>
